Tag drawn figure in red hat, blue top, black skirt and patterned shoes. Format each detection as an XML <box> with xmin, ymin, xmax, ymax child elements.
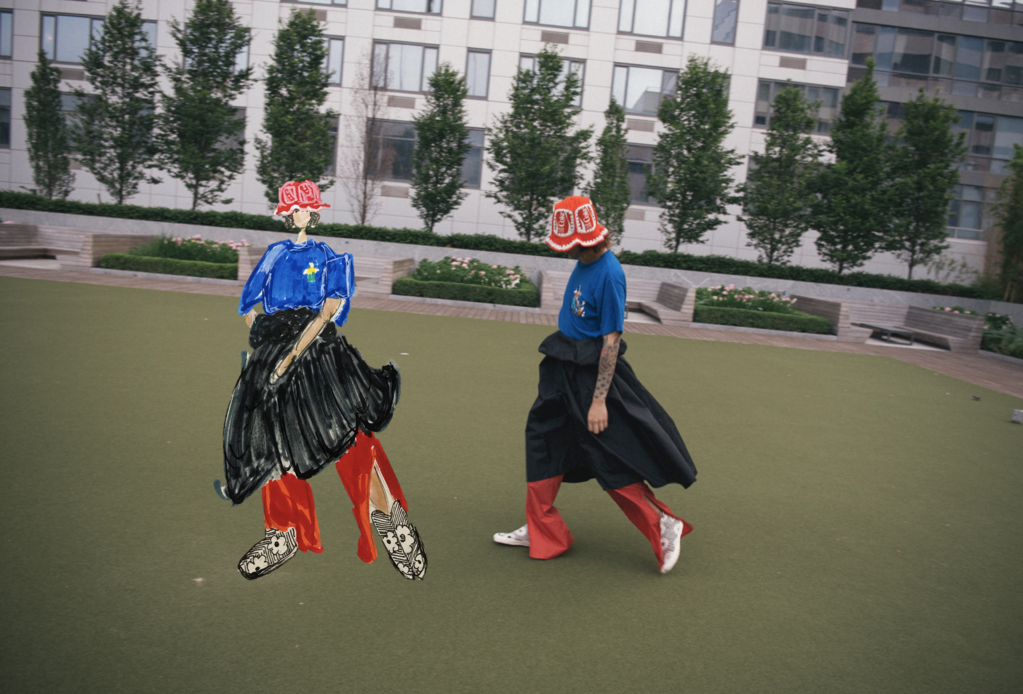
<box><xmin>214</xmin><ymin>181</ymin><xmax>427</xmax><ymax>579</ymax></box>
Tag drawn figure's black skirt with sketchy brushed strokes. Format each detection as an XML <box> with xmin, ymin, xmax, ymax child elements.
<box><xmin>224</xmin><ymin>308</ymin><xmax>401</xmax><ymax>504</ymax></box>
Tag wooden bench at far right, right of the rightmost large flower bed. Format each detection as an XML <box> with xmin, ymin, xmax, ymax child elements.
<box><xmin>793</xmin><ymin>296</ymin><xmax>984</xmax><ymax>354</ymax></box>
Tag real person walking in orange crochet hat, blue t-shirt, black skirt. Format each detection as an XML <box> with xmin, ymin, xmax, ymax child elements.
<box><xmin>494</xmin><ymin>197</ymin><xmax>697</xmax><ymax>573</ymax></box>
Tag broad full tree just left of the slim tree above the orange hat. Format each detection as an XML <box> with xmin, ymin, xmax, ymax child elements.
<box><xmin>485</xmin><ymin>46</ymin><xmax>593</xmax><ymax>241</ymax></box>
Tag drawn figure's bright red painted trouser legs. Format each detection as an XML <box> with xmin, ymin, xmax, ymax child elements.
<box><xmin>257</xmin><ymin>432</ymin><xmax>408</xmax><ymax>564</ymax></box>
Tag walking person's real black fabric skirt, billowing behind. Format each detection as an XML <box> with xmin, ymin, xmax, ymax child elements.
<box><xmin>526</xmin><ymin>332</ymin><xmax>697</xmax><ymax>490</ymax></box>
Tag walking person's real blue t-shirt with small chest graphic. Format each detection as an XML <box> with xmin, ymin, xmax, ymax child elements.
<box><xmin>558</xmin><ymin>251</ymin><xmax>625</xmax><ymax>340</ymax></box>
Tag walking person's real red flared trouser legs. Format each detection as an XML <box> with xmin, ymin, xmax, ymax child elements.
<box><xmin>526</xmin><ymin>475</ymin><xmax>688</xmax><ymax>566</ymax></box>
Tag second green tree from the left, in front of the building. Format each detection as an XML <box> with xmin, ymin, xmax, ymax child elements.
<box><xmin>73</xmin><ymin>0</ymin><xmax>160</xmax><ymax>205</ymax></box>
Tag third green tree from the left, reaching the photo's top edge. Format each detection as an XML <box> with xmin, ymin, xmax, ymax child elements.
<box><xmin>154</xmin><ymin>0</ymin><xmax>252</xmax><ymax>210</ymax></box>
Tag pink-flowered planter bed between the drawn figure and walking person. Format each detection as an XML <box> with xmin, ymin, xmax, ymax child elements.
<box><xmin>391</xmin><ymin>257</ymin><xmax>540</xmax><ymax>306</ymax></box>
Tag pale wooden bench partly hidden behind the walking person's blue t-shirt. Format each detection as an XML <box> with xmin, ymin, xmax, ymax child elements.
<box><xmin>539</xmin><ymin>270</ymin><xmax>697</xmax><ymax>328</ymax></box>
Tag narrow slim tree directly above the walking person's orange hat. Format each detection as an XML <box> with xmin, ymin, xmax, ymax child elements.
<box><xmin>583</xmin><ymin>96</ymin><xmax>631</xmax><ymax>246</ymax></box>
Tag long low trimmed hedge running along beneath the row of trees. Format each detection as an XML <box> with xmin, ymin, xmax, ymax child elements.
<box><xmin>0</xmin><ymin>190</ymin><xmax>1000</xmax><ymax>299</ymax></box>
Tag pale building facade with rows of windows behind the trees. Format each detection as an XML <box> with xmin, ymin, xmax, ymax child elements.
<box><xmin>0</xmin><ymin>0</ymin><xmax>1023</xmax><ymax>276</ymax></box>
